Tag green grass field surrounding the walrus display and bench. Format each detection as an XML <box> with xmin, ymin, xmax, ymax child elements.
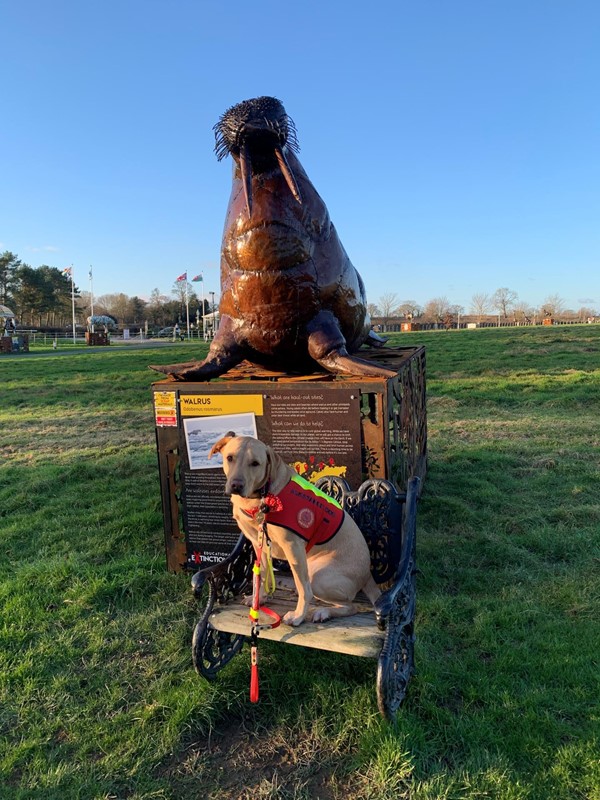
<box><xmin>0</xmin><ymin>326</ymin><xmax>600</xmax><ymax>800</ymax></box>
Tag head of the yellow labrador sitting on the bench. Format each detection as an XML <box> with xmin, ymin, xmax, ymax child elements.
<box><xmin>208</xmin><ymin>431</ymin><xmax>273</xmax><ymax>497</ymax></box>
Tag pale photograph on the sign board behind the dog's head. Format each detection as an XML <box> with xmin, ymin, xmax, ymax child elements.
<box><xmin>183</xmin><ymin>413</ymin><xmax>258</xmax><ymax>469</ymax></box>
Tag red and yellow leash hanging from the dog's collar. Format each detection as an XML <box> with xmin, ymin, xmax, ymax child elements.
<box><xmin>247</xmin><ymin>504</ymin><xmax>281</xmax><ymax>703</ymax></box>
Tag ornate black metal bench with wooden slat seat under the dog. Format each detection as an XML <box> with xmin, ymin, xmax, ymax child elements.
<box><xmin>192</xmin><ymin>477</ymin><xmax>420</xmax><ymax>720</ymax></box>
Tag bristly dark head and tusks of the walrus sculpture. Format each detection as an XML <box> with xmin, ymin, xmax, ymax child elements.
<box><xmin>214</xmin><ymin>97</ymin><xmax>302</xmax><ymax>216</ymax></box>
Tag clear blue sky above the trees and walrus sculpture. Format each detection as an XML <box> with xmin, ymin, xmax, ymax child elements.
<box><xmin>0</xmin><ymin>0</ymin><xmax>600</xmax><ymax>310</ymax></box>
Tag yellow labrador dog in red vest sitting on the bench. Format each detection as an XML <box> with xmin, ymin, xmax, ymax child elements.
<box><xmin>209</xmin><ymin>433</ymin><xmax>380</xmax><ymax>625</ymax></box>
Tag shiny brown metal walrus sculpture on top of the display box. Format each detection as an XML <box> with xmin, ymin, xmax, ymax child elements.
<box><xmin>152</xmin><ymin>97</ymin><xmax>395</xmax><ymax>380</ymax></box>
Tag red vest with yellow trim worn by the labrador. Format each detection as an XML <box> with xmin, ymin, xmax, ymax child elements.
<box><xmin>244</xmin><ymin>475</ymin><xmax>344</xmax><ymax>552</ymax></box>
